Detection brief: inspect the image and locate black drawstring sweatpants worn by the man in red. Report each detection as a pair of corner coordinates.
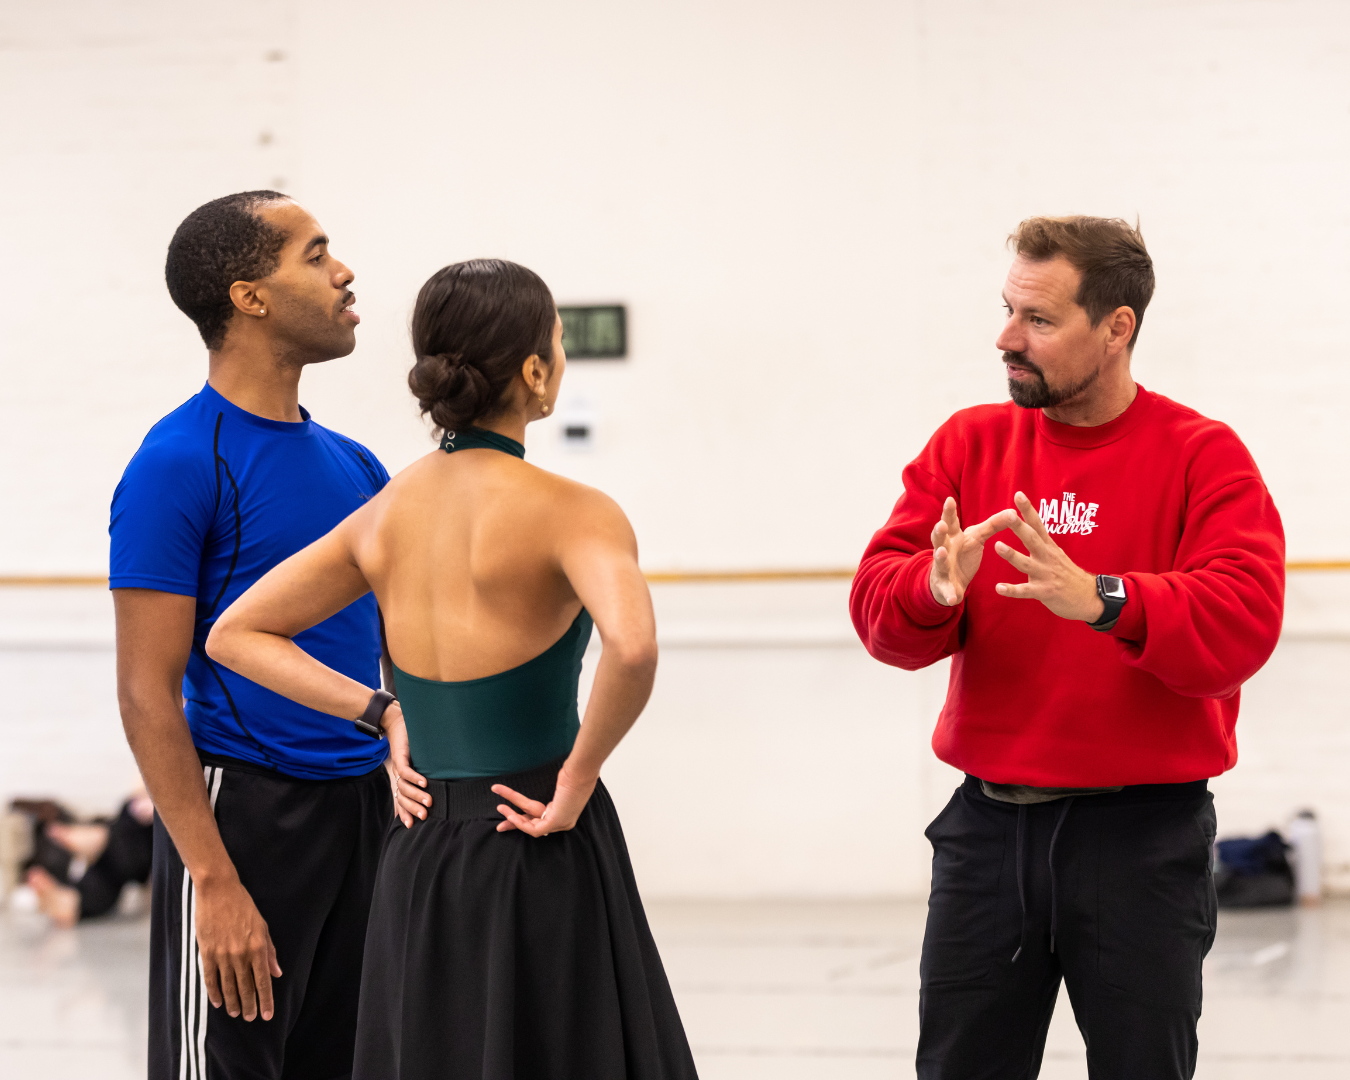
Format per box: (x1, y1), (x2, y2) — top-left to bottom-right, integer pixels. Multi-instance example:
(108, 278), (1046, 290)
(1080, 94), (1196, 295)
(918, 776), (1216, 1080)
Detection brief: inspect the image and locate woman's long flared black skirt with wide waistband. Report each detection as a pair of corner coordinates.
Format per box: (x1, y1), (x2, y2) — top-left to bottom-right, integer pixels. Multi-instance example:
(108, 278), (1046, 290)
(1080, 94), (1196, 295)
(352, 761), (697, 1080)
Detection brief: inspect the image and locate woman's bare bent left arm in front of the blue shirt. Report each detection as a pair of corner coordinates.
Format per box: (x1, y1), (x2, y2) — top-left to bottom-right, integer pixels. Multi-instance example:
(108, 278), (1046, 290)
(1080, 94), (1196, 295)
(207, 518), (431, 826)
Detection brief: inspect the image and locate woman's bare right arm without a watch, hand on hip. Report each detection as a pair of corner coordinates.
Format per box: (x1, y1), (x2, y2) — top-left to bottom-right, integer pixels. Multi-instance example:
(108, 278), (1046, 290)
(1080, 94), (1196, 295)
(493, 493), (656, 837)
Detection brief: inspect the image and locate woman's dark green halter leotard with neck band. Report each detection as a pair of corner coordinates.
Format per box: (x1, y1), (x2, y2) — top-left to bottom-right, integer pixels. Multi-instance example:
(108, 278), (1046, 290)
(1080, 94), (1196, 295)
(394, 428), (591, 780)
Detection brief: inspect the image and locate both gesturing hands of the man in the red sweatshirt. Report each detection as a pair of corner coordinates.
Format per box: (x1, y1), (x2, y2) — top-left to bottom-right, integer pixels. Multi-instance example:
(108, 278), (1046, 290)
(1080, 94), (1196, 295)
(929, 491), (1104, 622)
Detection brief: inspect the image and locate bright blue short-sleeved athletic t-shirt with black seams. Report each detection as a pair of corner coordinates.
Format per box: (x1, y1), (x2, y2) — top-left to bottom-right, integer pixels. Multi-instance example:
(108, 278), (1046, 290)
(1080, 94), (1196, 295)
(108, 383), (389, 779)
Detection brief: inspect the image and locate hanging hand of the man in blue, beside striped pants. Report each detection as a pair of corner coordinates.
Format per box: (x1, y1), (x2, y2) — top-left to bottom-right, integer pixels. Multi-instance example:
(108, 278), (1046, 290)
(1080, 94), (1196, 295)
(195, 878), (281, 1021)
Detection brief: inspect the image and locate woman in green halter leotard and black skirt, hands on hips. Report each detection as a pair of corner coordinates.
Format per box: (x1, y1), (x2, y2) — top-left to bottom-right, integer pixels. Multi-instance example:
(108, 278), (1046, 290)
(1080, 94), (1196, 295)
(207, 261), (695, 1080)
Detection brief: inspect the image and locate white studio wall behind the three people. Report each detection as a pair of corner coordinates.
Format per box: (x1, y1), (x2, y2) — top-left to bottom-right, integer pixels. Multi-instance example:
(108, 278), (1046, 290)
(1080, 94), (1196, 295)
(0, 0), (1350, 894)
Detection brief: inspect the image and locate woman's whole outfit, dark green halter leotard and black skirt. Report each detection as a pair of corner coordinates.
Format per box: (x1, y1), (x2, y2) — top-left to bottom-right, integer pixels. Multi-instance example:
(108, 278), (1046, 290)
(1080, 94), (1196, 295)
(352, 428), (697, 1080)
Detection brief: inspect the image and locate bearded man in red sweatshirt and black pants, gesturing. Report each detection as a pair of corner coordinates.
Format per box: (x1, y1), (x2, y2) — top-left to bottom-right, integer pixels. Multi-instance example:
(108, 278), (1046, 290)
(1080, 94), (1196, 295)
(851, 217), (1284, 1080)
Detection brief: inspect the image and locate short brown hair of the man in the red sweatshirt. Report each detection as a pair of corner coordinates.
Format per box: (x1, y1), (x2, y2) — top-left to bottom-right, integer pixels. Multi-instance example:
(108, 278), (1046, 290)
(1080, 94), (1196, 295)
(1008, 215), (1153, 348)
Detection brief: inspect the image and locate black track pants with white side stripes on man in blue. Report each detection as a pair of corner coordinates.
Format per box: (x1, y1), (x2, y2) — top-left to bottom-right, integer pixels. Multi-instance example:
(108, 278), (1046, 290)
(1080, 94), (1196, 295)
(149, 757), (393, 1080)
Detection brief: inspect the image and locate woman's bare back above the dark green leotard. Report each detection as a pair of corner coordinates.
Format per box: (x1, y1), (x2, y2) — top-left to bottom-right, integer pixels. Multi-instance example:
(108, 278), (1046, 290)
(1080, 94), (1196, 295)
(350, 448), (607, 682)
